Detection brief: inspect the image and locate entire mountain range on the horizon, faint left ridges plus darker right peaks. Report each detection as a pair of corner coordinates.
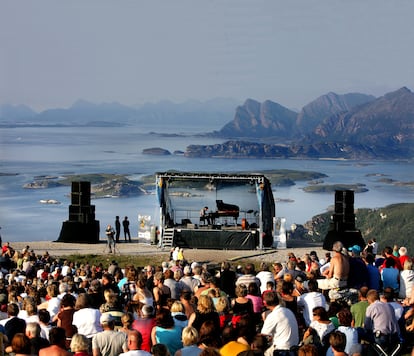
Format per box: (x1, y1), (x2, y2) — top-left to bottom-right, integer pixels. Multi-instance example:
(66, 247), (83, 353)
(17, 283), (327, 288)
(0, 87), (414, 159)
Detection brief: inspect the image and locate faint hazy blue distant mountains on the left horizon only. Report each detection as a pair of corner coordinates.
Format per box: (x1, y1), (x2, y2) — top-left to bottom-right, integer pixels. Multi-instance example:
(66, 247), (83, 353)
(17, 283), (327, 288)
(0, 98), (238, 130)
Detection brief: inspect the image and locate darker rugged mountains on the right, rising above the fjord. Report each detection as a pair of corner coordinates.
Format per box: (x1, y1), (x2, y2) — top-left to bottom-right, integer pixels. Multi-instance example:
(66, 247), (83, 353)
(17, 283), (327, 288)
(209, 87), (414, 159)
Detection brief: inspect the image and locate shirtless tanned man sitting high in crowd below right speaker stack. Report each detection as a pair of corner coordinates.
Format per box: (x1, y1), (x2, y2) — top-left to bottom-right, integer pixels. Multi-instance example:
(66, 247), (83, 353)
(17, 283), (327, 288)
(317, 241), (349, 290)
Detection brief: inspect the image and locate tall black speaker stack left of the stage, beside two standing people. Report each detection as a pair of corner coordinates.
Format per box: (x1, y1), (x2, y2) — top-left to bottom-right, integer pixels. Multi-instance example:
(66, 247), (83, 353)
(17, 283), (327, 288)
(58, 181), (99, 243)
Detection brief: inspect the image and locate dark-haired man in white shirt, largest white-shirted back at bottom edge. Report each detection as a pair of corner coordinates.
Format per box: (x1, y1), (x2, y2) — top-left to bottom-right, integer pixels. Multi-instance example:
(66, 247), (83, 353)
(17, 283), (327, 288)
(261, 291), (299, 356)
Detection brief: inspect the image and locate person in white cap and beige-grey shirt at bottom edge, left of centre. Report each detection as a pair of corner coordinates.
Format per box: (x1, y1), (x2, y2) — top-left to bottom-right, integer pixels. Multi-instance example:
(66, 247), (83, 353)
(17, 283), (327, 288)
(92, 313), (127, 356)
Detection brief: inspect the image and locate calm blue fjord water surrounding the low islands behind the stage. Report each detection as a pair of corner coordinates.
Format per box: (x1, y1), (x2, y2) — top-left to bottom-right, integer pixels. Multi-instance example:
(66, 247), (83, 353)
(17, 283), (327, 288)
(0, 124), (414, 242)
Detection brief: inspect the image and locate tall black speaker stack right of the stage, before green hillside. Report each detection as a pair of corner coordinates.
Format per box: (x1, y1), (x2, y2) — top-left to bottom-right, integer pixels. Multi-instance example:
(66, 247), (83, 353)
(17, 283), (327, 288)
(323, 190), (365, 251)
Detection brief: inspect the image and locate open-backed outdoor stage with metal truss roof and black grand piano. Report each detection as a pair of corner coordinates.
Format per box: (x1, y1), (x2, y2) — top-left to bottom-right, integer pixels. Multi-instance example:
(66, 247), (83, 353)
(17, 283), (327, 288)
(156, 172), (275, 250)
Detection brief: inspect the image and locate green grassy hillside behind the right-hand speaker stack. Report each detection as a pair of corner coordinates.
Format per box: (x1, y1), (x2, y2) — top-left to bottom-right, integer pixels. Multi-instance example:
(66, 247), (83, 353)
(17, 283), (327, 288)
(305, 203), (414, 256)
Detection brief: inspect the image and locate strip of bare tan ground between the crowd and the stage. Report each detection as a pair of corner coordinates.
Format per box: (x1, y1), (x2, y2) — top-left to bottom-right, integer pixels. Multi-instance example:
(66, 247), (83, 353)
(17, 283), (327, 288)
(11, 240), (326, 263)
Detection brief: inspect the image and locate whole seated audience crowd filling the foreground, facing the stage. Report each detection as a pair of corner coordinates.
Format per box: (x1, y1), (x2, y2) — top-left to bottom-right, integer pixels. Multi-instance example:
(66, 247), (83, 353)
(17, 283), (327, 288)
(0, 241), (414, 356)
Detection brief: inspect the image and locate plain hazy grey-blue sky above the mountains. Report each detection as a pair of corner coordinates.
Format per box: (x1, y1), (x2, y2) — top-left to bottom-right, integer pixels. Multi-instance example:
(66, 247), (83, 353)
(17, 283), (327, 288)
(0, 0), (414, 110)
